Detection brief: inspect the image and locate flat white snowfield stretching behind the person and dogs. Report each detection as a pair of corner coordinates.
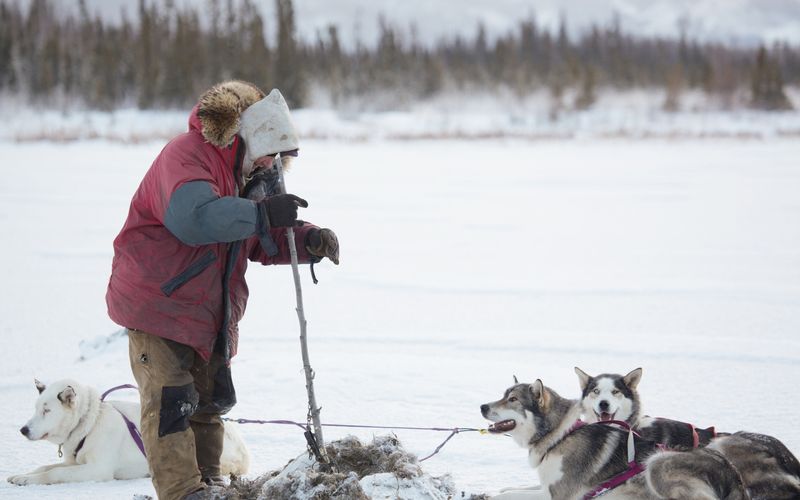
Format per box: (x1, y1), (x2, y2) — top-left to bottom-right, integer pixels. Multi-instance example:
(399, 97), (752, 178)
(0, 138), (800, 499)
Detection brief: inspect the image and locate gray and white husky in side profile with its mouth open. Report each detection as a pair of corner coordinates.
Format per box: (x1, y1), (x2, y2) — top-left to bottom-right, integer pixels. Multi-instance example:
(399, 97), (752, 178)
(481, 380), (749, 500)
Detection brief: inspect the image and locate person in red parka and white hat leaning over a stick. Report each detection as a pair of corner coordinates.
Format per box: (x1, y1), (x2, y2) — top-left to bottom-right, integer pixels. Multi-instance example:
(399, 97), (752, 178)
(106, 81), (339, 500)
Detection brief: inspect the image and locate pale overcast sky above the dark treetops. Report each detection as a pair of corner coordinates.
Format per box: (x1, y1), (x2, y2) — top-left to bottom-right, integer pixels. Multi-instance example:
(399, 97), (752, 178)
(28, 0), (800, 45)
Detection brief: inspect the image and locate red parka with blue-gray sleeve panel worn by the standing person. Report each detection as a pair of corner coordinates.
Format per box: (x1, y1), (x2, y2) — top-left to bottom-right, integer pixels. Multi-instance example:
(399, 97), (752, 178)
(106, 86), (314, 359)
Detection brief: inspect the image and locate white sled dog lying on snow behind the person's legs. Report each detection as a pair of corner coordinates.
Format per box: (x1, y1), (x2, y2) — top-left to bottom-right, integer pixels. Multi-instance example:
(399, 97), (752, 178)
(8, 379), (250, 485)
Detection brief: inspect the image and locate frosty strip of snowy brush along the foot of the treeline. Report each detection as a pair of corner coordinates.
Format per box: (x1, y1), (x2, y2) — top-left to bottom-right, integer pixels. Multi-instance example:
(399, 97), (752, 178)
(0, 87), (800, 144)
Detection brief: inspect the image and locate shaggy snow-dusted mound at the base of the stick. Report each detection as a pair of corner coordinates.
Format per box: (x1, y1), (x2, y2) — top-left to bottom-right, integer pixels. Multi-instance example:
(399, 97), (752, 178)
(227, 436), (456, 500)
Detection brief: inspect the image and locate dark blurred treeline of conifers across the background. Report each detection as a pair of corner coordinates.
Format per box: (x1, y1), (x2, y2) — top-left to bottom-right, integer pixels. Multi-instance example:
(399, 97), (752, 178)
(0, 0), (800, 109)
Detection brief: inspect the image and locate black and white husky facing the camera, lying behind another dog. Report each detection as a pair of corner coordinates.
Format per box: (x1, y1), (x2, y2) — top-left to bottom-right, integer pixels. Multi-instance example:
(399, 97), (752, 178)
(575, 367), (800, 500)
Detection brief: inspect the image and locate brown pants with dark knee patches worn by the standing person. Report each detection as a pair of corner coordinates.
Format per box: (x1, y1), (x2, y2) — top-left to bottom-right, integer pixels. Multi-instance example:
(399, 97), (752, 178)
(128, 330), (236, 500)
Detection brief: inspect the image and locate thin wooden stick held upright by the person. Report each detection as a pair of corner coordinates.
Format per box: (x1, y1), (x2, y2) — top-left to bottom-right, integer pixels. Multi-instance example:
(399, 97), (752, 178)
(275, 155), (328, 465)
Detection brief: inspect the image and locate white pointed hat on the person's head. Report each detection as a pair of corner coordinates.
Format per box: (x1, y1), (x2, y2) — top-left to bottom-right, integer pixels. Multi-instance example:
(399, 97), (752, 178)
(239, 89), (298, 163)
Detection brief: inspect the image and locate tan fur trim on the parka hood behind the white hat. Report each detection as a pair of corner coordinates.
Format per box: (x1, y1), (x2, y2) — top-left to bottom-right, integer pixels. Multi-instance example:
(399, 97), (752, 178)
(197, 80), (265, 148)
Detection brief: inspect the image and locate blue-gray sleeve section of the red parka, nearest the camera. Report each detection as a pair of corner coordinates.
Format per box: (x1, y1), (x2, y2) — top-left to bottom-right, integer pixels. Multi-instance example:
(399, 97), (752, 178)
(164, 181), (258, 246)
